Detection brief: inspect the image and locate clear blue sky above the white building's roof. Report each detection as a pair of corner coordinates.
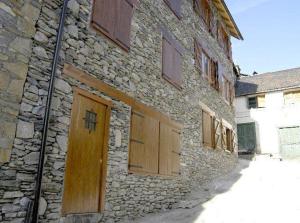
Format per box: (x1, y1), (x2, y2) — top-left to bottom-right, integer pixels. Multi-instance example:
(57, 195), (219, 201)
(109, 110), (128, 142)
(225, 0), (300, 74)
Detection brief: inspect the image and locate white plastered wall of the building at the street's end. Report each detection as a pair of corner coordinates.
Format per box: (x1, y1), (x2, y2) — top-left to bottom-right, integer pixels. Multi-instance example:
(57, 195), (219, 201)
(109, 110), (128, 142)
(235, 92), (300, 154)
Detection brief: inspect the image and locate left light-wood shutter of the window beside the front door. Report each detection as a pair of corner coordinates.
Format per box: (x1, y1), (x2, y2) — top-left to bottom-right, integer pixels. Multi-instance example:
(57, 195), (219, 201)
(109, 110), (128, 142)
(129, 111), (159, 173)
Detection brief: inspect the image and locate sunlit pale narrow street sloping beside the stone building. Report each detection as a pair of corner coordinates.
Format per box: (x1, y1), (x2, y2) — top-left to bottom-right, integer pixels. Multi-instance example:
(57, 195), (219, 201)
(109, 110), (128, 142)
(135, 157), (300, 223)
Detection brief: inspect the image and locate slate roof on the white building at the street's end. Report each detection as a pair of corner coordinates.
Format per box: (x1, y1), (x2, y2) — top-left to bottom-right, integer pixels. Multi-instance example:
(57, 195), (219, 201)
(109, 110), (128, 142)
(235, 67), (300, 97)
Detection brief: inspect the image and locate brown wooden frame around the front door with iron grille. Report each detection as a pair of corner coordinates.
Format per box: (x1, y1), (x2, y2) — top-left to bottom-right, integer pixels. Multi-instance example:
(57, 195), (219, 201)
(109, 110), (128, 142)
(62, 87), (113, 216)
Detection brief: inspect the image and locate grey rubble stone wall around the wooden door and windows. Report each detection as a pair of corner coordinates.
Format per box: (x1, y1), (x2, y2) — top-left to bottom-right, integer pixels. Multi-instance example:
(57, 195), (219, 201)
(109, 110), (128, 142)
(0, 0), (236, 222)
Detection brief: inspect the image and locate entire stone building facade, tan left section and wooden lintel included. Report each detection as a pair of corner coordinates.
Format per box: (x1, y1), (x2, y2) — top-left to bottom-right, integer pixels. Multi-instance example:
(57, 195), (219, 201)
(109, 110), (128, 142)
(0, 0), (241, 222)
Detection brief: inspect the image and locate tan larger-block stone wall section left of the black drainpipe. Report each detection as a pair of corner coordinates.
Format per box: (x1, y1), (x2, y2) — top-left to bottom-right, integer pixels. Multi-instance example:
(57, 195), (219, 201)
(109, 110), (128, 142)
(0, 0), (41, 165)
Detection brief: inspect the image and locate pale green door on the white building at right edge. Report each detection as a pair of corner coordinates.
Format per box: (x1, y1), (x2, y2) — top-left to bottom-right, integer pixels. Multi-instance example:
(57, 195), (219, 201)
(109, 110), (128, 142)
(279, 126), (300, 158)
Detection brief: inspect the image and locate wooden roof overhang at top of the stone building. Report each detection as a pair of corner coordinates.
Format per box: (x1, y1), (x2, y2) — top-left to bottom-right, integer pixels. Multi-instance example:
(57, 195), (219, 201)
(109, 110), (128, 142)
(213, 0), (244, 40)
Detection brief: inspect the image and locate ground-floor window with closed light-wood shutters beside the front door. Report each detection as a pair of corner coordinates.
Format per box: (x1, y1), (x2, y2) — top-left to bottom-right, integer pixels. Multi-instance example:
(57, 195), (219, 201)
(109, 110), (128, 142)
(129, 111), (180, 176)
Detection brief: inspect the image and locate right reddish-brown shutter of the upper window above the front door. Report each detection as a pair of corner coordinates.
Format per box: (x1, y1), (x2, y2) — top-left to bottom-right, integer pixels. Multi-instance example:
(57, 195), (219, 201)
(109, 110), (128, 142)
(115, 0), (133, 49)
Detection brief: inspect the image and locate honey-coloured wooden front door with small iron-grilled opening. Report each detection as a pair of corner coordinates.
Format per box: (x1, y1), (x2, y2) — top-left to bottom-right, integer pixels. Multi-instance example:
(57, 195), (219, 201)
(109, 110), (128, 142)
(62, 88), (111, 214)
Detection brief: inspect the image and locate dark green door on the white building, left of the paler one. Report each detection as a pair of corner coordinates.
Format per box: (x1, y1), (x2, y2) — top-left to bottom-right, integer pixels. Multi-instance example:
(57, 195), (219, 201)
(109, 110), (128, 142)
(237, 122), (256, 153)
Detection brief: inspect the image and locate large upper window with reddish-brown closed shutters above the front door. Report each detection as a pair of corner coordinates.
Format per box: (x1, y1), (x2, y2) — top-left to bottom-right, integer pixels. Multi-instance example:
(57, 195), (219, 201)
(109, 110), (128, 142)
(91, 0), (136, 51)
